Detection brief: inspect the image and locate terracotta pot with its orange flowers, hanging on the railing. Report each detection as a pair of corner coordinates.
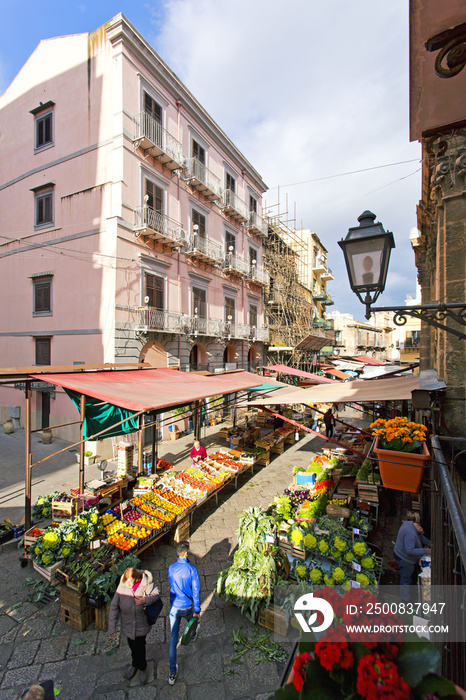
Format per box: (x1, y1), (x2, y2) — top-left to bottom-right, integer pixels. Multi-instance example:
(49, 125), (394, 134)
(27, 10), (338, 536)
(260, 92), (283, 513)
(371, 417), (430, 493)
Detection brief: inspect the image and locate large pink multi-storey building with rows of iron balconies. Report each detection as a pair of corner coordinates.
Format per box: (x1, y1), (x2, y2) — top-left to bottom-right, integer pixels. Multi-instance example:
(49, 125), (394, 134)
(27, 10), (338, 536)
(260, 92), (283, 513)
(0, 14), (268, 438)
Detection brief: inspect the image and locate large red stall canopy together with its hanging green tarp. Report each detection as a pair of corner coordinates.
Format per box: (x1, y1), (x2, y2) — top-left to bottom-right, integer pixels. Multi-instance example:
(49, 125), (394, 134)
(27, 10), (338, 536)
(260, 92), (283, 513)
(30, 369), (264, 439)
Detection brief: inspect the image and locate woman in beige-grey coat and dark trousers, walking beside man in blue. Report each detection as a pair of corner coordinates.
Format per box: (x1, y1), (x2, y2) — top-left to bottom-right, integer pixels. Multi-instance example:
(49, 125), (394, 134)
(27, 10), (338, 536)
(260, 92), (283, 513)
(108, 567), (160, 685)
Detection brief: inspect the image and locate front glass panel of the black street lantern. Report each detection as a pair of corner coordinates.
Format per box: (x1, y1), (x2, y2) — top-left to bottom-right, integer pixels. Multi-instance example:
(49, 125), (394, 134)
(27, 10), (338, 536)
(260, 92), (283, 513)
(346, 238), (385, 288)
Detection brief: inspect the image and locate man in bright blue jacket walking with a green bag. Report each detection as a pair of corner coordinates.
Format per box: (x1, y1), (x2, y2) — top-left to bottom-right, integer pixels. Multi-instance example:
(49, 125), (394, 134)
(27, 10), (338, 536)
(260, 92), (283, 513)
(168, 542), (201, 685)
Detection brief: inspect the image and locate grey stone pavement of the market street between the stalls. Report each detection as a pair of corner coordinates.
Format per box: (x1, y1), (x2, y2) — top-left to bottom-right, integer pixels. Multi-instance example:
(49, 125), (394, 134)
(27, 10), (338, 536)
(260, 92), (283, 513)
(0, 417), (386, 700)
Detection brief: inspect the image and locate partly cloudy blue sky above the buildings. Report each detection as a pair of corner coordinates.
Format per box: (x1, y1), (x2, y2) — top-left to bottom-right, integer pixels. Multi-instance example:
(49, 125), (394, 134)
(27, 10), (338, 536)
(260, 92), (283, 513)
(0, 0), (421, 320)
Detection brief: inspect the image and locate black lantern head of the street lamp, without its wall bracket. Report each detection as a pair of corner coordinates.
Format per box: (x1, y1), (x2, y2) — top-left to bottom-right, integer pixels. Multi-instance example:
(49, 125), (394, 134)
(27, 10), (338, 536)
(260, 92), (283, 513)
(338, 211), (395, 318)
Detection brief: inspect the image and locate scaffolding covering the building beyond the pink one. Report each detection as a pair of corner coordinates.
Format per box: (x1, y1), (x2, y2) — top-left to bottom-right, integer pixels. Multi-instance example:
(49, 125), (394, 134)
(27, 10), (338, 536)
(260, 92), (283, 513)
(264, 197), (333, 369)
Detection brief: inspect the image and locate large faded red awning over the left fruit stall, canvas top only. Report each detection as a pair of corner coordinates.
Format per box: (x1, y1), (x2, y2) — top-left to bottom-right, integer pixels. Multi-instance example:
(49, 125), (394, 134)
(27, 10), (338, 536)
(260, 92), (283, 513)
(30, 369), (264, 411)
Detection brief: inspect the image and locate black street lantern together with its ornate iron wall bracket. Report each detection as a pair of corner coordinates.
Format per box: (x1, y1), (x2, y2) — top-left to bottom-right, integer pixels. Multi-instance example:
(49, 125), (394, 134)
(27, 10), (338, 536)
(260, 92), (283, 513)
(338, 211), (466, 340)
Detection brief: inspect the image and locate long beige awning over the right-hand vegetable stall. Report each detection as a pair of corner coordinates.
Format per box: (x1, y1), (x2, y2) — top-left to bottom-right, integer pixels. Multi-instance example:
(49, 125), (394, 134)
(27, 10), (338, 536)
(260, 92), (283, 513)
(251, 377), (434, 406)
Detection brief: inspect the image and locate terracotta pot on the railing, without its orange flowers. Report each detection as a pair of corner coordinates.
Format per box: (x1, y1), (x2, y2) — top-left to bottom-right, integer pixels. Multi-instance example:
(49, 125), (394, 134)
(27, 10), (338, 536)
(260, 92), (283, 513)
(374, 438), (430, 493)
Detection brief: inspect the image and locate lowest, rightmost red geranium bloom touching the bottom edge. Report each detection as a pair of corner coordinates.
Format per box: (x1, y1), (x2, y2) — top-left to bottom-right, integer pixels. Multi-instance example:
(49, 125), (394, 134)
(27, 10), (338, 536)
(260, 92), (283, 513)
(356, 654), (411, 700)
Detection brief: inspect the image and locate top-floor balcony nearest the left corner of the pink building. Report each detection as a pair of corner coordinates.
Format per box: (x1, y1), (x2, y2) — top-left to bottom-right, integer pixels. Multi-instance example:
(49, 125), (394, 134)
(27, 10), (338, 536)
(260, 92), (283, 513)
(133, 112), (184, 170)
